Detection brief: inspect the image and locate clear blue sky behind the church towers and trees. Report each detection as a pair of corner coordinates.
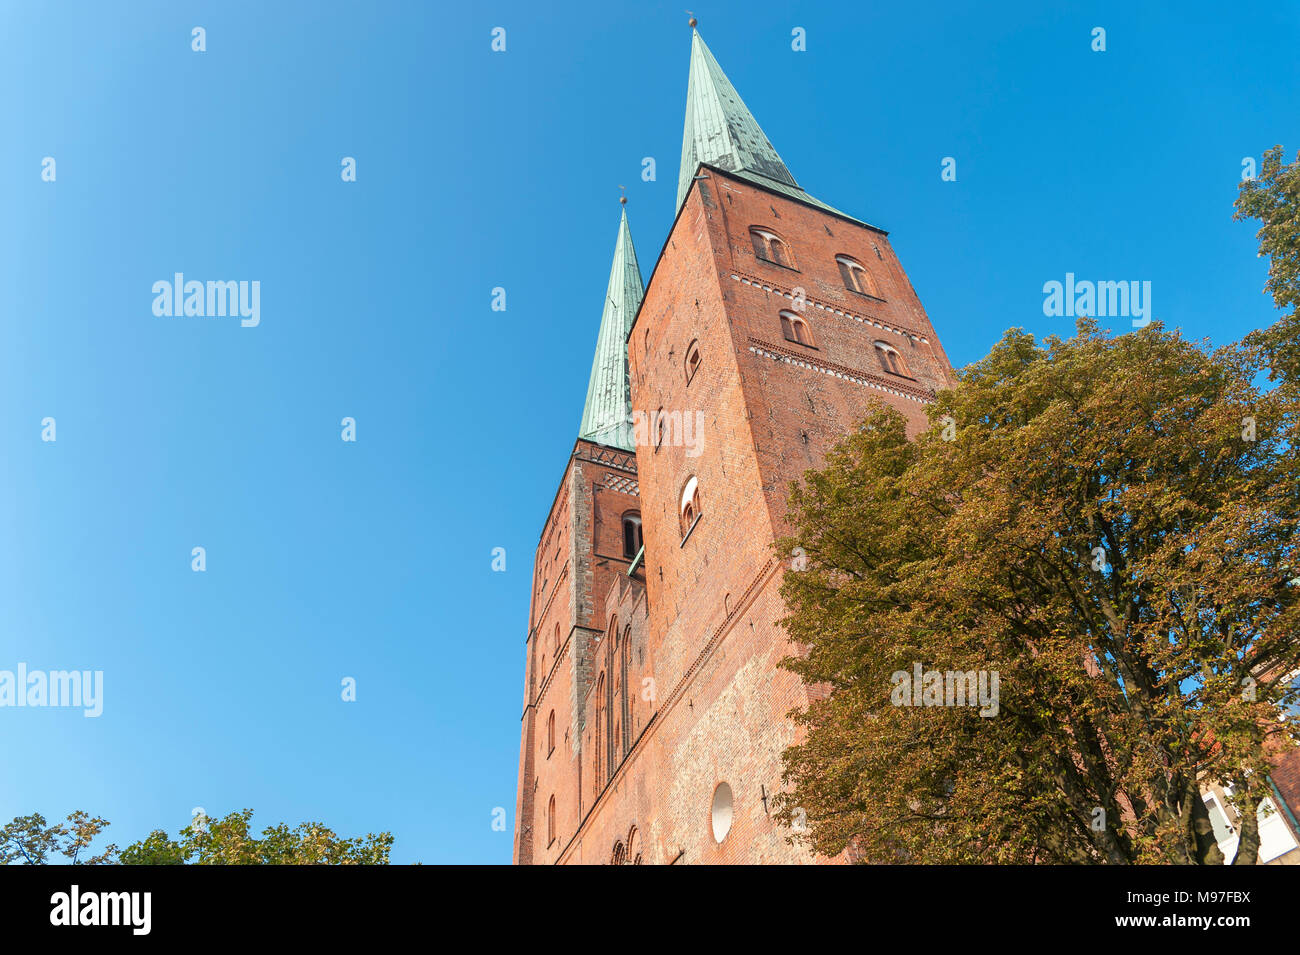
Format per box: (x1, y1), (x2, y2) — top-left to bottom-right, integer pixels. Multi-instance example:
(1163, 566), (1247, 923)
(0, 0), (1300, 863)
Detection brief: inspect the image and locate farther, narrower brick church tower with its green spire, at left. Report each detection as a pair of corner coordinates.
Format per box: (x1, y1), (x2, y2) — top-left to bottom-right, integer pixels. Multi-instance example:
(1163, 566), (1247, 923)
(515, 209), (645, 864)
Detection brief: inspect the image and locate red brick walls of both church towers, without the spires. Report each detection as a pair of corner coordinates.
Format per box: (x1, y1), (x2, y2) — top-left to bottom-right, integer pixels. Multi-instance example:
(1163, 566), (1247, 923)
(515, 165), (953, 864)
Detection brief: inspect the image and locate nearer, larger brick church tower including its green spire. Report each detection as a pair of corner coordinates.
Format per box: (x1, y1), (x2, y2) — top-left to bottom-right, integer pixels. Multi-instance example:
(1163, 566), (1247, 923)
(514, 23), (954, 864)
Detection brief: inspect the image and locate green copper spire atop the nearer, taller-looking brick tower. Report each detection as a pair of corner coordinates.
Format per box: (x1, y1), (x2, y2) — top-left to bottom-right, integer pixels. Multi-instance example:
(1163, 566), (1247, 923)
(677, 30), (837, 212)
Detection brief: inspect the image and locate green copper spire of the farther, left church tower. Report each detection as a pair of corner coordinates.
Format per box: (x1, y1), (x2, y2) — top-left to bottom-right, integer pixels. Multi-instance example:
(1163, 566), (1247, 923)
(579, 209), (645, 451)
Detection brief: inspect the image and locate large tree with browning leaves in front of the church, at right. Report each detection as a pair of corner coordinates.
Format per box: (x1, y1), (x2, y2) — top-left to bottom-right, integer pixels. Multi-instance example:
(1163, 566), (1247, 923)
(779, 149), (1300, 864)
